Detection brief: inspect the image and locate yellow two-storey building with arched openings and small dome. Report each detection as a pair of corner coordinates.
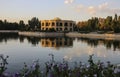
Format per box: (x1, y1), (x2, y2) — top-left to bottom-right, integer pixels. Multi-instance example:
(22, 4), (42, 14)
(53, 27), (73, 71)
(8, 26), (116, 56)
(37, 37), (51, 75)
(41, 17), (75, 32)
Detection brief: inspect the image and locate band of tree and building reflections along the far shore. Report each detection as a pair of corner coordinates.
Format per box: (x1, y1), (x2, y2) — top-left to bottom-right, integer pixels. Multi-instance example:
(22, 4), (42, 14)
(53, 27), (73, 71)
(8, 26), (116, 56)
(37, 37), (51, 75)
(0, 33), (120, 51)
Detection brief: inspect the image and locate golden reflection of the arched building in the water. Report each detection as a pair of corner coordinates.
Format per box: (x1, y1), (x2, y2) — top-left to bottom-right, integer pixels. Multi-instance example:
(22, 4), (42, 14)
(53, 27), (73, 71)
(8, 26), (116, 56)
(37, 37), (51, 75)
(41, 37), (73, 48)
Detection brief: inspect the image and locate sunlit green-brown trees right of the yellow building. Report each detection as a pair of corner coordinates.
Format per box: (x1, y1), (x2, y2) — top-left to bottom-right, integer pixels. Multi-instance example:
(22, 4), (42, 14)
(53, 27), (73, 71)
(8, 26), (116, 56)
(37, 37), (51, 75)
(75, 14), (120, 33)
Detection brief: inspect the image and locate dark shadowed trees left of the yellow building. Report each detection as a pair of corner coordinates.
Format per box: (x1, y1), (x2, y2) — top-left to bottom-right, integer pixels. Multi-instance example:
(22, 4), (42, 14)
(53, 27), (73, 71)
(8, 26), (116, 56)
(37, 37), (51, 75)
(0, 17), (40, 31)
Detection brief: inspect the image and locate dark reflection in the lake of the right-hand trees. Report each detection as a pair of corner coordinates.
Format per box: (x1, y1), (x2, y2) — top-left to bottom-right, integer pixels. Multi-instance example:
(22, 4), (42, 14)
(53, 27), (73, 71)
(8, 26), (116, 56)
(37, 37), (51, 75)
(77, 38), (120, 51)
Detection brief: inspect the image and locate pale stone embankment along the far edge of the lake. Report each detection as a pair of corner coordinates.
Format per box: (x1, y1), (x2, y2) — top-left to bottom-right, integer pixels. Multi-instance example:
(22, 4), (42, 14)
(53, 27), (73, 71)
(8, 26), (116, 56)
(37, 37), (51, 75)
(0, 30), (120, 40)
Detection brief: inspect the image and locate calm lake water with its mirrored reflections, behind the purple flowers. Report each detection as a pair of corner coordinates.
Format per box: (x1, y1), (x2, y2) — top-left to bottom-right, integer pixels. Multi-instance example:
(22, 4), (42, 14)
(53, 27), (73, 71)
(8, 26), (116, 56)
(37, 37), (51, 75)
(0, 33), (120, 72)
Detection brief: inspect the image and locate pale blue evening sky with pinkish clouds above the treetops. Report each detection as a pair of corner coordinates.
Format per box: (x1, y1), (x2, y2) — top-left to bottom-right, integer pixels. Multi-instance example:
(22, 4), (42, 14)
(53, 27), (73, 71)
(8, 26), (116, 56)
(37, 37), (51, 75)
(0, 0), (120, 23)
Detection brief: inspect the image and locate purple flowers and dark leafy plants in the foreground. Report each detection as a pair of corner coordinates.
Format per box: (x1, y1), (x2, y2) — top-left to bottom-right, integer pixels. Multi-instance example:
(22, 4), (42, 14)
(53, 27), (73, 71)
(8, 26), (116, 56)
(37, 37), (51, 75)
(0, 54), (120, 77)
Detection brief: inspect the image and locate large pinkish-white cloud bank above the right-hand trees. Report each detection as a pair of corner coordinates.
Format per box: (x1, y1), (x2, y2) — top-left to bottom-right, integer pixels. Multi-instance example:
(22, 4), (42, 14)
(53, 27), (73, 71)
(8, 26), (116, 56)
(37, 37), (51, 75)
(74, 2), (120, 15)
